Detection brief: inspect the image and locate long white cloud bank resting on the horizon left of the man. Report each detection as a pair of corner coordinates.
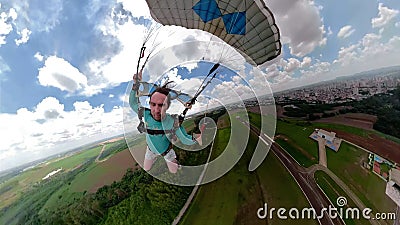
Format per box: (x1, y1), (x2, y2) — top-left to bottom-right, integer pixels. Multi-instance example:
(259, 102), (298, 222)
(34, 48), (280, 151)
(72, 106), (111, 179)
(0, 97), (123, 170)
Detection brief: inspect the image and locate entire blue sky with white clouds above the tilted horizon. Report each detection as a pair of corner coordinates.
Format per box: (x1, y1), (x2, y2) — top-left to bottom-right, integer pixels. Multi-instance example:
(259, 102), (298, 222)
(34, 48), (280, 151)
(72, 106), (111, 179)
(0, 0), (400, 171)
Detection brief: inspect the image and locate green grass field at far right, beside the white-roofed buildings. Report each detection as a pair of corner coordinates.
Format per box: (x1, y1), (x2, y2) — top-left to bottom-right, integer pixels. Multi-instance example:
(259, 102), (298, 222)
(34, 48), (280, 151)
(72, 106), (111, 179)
(327, 142), (395, 215)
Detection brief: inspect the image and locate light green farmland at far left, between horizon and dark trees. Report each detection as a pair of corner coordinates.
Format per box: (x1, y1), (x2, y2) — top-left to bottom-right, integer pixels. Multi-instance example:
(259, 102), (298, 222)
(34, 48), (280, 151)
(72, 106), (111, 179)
(0, 139), (138, 224)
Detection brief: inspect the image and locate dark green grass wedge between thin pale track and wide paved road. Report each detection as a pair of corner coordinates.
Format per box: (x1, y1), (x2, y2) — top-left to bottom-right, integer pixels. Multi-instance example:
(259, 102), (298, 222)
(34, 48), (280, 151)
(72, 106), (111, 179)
(180, 120), (317, 224)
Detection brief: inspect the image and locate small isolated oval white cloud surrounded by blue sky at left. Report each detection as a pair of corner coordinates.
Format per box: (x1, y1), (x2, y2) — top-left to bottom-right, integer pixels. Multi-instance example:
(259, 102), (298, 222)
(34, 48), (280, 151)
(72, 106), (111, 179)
(38, 56), (87, 93)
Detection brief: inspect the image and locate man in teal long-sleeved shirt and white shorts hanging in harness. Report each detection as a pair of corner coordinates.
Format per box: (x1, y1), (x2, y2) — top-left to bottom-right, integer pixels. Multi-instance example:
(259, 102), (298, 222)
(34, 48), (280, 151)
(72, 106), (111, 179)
(129, 71), (201, 173)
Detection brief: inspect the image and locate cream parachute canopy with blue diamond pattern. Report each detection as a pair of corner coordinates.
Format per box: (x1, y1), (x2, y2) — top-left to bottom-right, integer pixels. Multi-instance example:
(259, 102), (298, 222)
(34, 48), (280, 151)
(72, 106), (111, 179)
(146, 0), (281, 65)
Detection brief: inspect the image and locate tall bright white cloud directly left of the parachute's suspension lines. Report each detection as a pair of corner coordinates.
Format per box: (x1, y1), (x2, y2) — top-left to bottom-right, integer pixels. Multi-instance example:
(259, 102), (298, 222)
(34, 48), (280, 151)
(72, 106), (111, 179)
(81, 1), (155, 96)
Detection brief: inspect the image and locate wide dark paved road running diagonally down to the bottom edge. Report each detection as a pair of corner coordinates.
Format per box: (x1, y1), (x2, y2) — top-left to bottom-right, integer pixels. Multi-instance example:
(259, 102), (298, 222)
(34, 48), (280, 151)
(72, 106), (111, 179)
(243, 120), (345, 225)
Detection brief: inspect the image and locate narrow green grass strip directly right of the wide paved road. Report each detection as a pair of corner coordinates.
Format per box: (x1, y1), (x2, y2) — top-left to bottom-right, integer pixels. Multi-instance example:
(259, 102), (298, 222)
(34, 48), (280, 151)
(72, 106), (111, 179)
(315, 171), (369, 225)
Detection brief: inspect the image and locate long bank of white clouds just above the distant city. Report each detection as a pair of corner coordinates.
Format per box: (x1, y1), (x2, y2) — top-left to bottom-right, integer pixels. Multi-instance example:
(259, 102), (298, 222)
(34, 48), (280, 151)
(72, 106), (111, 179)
(274, 27), (400, 91)
